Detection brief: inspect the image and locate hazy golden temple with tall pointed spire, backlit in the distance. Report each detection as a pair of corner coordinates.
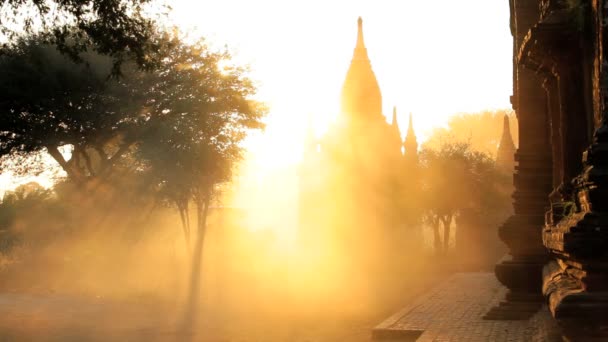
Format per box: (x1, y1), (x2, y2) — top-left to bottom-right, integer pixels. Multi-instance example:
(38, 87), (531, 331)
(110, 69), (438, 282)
(299, 18), (418, 264)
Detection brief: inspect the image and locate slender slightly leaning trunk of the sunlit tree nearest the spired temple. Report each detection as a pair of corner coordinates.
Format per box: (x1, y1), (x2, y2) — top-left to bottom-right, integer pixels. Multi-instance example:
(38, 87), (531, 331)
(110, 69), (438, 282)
(184, 198), (209, 340)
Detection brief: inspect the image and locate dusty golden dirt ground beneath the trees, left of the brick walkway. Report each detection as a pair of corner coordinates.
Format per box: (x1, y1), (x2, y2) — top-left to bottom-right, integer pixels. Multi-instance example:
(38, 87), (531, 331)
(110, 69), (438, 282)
(0, 278), (437, 342)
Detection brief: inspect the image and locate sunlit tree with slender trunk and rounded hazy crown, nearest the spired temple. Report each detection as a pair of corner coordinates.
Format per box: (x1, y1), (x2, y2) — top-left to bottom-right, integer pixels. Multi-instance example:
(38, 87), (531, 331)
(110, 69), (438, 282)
(138, 41), (265, 332)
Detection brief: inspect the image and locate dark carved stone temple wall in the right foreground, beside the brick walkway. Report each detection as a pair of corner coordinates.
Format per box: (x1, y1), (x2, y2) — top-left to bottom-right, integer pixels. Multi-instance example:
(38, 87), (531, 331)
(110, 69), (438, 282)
(491, 0), (608, 341)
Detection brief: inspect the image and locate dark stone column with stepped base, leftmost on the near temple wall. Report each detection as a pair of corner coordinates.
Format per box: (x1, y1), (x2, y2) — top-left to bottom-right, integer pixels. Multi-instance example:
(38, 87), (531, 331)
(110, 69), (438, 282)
(485, 0), (553, 319)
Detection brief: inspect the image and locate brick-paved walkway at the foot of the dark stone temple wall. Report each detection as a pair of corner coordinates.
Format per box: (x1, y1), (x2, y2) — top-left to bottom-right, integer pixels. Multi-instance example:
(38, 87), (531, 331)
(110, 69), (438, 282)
(373, 273), (557, 342)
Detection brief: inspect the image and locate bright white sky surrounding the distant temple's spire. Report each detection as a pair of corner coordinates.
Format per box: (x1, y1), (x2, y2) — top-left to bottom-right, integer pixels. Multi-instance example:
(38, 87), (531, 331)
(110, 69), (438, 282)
(171, 0), (512, 164)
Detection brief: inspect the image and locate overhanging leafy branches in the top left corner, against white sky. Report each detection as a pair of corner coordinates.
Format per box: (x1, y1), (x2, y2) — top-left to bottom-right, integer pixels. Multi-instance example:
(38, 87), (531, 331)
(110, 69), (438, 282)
(0, 0), (160, 74)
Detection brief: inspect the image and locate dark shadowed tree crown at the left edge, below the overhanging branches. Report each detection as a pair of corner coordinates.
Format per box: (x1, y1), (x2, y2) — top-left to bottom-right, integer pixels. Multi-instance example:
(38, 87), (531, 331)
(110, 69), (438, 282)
(0, 36), (150, 184)
